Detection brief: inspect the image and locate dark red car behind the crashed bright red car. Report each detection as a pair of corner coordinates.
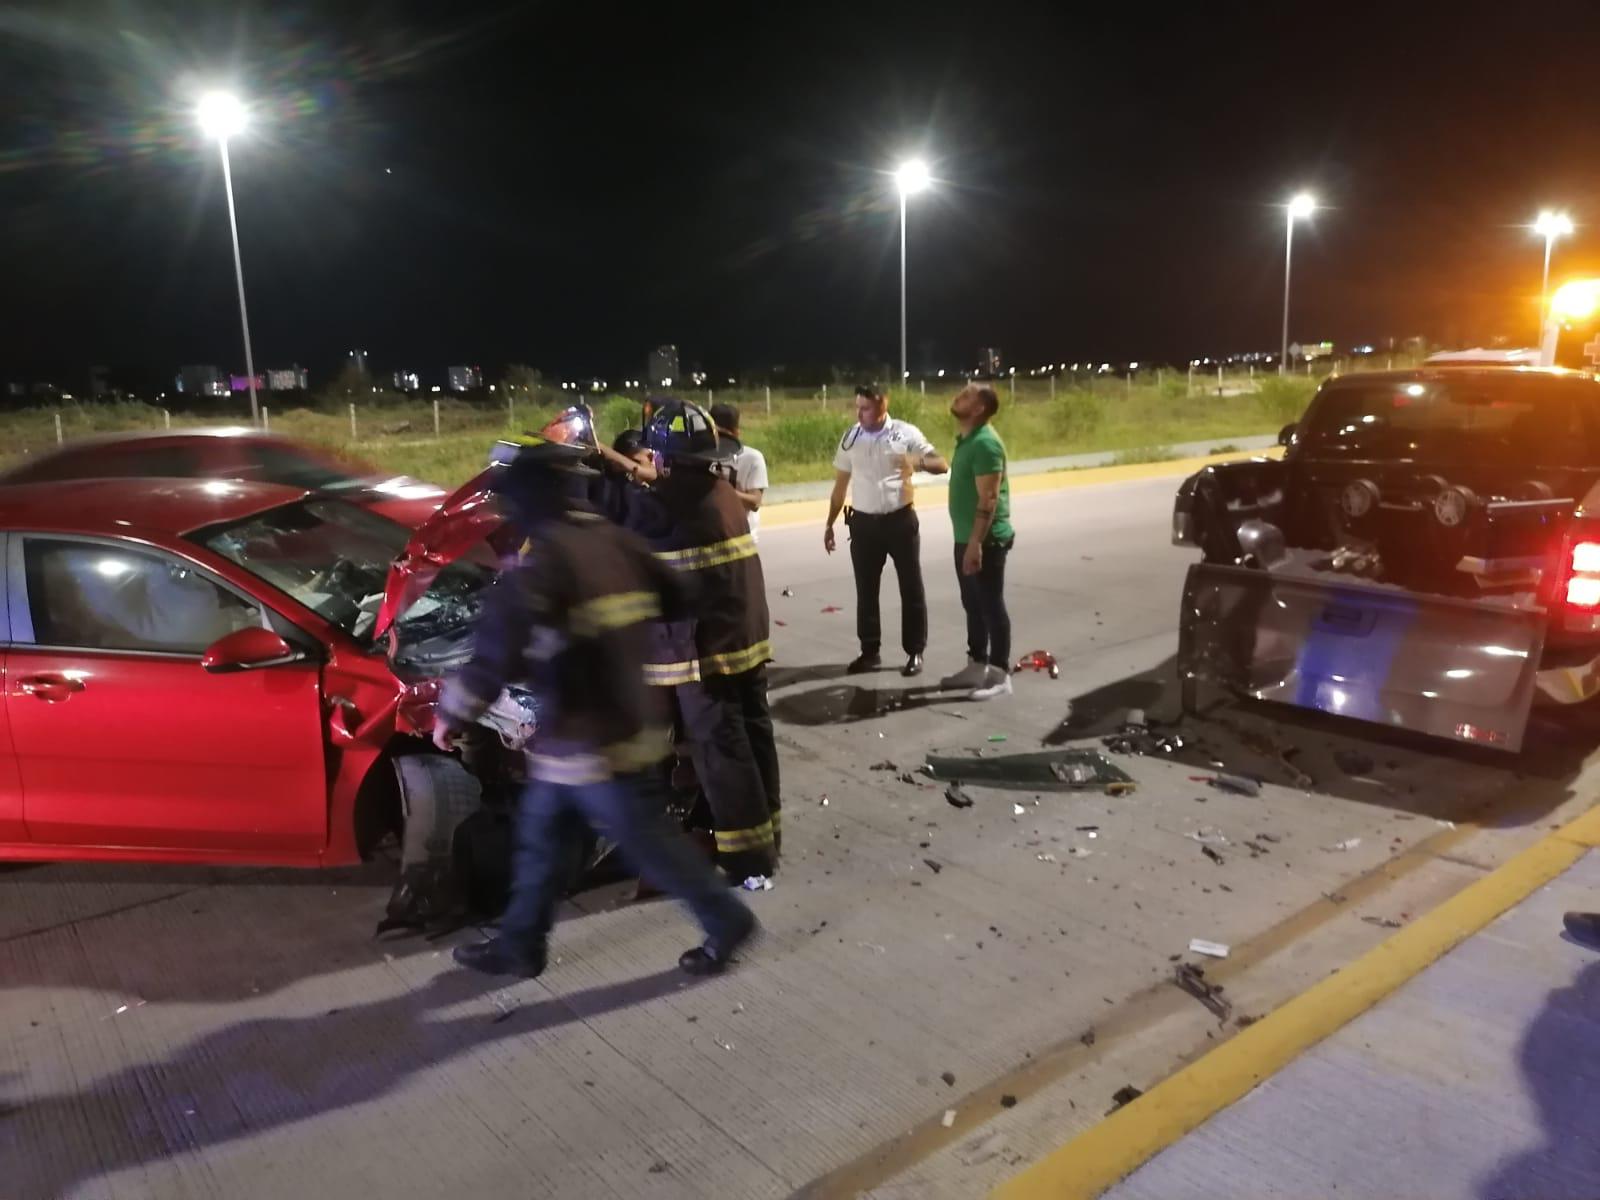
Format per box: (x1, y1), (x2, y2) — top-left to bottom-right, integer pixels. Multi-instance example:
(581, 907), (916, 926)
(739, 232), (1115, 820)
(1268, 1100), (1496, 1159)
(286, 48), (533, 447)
(0, 427), (445, 528)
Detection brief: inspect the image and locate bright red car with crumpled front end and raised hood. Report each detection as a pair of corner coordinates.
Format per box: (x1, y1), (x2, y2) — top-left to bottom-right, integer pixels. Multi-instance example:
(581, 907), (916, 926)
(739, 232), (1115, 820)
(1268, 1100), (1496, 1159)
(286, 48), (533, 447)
(0, 478), (533, 912)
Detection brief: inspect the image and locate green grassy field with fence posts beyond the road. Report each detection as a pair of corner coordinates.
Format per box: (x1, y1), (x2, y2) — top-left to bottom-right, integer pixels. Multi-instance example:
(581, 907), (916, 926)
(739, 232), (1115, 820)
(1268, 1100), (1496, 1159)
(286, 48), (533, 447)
(0, 371), (1318, 486)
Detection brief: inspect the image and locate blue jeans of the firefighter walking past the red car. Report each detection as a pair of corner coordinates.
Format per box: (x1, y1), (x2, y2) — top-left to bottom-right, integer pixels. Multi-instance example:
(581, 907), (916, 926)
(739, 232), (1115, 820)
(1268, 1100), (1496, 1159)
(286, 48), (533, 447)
(501, 773), (754, 946)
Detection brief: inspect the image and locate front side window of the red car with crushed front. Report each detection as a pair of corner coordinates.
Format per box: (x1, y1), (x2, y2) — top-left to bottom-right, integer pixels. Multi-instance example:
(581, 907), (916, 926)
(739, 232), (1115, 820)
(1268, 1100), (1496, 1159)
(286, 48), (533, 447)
(22, 538), (262, 654)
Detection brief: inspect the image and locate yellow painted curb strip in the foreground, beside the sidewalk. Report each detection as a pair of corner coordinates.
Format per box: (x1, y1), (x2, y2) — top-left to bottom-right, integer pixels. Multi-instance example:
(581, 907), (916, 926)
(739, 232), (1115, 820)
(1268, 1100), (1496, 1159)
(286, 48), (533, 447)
(992, 810), (1600, 1200)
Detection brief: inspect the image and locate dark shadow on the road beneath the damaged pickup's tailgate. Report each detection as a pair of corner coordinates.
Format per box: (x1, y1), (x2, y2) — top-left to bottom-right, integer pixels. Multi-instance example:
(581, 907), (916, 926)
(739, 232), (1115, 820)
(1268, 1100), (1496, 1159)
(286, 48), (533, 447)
(1043, 658), (1600, 826)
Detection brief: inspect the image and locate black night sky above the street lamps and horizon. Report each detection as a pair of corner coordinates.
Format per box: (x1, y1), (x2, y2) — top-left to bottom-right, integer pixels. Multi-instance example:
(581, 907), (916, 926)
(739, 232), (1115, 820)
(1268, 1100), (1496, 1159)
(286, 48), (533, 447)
(0, 0), (1600, 379)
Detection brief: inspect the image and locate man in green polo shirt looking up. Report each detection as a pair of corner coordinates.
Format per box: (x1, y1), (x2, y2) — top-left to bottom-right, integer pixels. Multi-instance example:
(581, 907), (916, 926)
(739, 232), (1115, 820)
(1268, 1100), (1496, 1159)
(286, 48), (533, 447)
(939, 384), (1016, 699)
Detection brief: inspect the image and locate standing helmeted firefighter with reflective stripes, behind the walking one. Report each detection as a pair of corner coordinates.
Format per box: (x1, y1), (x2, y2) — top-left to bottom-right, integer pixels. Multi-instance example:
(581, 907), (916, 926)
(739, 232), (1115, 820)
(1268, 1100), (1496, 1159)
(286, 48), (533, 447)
(645, 400), (782, 880)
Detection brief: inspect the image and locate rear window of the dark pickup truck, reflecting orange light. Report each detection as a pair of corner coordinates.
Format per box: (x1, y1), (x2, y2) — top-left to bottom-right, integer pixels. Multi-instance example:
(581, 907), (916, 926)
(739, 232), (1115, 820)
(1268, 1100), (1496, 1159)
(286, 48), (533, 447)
(1299, 371), (1600, 467)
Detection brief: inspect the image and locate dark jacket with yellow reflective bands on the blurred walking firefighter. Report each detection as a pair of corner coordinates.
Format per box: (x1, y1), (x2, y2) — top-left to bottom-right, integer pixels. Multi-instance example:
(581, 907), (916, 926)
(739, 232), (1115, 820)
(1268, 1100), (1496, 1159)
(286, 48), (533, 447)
(440, 510), (686, 784)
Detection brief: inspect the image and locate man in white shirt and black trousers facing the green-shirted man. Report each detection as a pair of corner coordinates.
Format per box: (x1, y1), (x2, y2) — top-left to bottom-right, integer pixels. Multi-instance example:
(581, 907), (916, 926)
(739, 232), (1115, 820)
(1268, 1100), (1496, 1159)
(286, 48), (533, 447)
(822, 384), (950, 677)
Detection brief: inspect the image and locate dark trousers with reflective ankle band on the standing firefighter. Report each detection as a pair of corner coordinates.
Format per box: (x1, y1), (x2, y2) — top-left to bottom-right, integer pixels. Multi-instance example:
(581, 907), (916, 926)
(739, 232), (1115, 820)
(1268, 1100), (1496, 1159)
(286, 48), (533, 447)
(677, 667), (782, 880)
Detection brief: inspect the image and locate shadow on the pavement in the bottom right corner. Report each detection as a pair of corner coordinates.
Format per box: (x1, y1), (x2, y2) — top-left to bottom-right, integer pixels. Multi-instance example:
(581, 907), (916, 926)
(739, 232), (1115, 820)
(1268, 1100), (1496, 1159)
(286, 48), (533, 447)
(1478, 962), (1600, 1200)
